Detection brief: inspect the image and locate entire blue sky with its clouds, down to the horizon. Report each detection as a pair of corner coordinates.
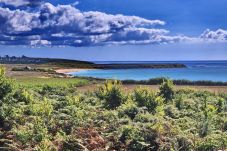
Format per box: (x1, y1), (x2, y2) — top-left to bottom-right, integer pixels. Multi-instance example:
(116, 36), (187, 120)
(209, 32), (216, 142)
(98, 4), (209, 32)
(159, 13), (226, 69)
(0, 0), (227, 61)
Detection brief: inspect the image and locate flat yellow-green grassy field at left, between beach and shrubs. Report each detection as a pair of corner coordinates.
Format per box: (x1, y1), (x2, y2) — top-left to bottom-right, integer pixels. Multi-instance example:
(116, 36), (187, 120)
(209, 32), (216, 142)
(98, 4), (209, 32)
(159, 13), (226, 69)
(1, 64), (94, 88)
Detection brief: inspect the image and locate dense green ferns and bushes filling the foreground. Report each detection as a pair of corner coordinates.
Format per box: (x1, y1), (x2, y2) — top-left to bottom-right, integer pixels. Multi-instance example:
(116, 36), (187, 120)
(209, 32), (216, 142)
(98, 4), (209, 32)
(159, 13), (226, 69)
(0, 68), (227, 151)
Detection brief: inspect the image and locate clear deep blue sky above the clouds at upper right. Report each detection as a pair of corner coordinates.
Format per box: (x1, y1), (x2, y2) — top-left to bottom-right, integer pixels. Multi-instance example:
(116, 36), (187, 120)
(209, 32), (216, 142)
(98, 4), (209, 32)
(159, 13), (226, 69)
(49, 0), (227, 35)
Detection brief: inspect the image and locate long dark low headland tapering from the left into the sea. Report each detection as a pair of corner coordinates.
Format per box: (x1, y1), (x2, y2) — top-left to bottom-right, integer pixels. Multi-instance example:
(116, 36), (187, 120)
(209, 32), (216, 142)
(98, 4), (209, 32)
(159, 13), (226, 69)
(0, 56), (186, 69)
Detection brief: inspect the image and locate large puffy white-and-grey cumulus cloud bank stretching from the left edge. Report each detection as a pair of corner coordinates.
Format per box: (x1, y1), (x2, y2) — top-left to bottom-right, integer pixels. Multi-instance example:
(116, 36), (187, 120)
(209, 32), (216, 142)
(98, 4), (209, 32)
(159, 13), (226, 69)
(0, 0), (209, 47)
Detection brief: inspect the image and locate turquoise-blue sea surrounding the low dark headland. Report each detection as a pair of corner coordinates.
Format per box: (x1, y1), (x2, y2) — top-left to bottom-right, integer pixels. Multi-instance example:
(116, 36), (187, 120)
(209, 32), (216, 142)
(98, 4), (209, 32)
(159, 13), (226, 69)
(70, 61), (227, 82)
